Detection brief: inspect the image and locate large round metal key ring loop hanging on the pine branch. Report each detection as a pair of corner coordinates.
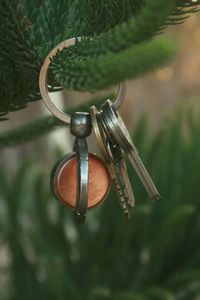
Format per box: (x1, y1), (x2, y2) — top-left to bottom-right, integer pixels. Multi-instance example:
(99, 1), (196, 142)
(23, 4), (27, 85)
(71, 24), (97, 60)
(39, 37), (126, 124)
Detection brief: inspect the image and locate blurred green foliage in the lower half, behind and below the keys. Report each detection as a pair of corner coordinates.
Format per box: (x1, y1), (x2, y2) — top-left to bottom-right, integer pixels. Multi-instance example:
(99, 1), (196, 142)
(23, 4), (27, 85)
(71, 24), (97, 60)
(0, 106), (200, 300)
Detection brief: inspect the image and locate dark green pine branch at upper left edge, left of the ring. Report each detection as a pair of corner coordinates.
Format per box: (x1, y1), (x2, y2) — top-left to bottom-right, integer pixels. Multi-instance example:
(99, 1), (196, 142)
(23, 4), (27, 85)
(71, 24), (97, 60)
(0, 0), (41, 114)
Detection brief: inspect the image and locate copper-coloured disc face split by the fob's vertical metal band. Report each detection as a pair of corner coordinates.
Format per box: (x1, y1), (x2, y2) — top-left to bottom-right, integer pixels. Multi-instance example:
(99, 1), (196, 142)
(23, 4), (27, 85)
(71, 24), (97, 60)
(53, 153), (111, 208)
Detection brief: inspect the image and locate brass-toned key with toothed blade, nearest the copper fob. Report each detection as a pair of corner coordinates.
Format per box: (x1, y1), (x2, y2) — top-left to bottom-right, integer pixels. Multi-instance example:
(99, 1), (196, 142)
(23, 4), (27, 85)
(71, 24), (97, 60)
(90, 106), (129, 218)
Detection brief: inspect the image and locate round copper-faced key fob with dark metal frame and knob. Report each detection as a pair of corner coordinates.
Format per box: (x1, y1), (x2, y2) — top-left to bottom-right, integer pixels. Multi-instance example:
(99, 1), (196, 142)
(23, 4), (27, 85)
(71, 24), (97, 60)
(50, 112), (111, 224)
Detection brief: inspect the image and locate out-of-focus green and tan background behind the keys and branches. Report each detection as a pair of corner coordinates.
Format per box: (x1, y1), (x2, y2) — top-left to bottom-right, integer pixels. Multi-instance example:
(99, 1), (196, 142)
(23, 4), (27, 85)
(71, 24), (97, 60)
(0, 5), (200, 300)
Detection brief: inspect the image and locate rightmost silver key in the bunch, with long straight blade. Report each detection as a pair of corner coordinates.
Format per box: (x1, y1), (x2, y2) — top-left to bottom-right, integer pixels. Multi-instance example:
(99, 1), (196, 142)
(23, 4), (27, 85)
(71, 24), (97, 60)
(100, 100), (160, 200)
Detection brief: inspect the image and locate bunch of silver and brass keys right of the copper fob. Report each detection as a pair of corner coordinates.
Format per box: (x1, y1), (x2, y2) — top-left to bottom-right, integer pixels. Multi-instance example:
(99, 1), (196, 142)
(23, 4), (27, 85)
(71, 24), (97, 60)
(90, 100), (160, 217)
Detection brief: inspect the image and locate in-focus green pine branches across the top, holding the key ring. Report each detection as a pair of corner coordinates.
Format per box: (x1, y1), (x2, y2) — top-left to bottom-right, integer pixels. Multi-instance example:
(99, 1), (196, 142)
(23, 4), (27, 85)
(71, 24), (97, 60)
(0, 0), (200, 120)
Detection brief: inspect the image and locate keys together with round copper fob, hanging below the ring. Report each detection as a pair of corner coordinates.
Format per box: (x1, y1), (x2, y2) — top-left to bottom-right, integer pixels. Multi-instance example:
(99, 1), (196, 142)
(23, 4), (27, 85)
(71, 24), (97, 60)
(51, 100), (160, 224)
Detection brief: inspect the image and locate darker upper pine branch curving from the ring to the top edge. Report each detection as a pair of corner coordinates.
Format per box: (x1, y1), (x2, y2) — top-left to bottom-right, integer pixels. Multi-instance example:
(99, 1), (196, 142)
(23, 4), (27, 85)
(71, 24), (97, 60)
(55, 0), (174, 59)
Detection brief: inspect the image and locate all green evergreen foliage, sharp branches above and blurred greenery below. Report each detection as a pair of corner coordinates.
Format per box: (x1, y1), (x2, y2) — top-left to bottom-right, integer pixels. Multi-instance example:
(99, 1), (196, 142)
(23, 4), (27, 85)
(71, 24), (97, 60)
(0, 0), (200, 300)
